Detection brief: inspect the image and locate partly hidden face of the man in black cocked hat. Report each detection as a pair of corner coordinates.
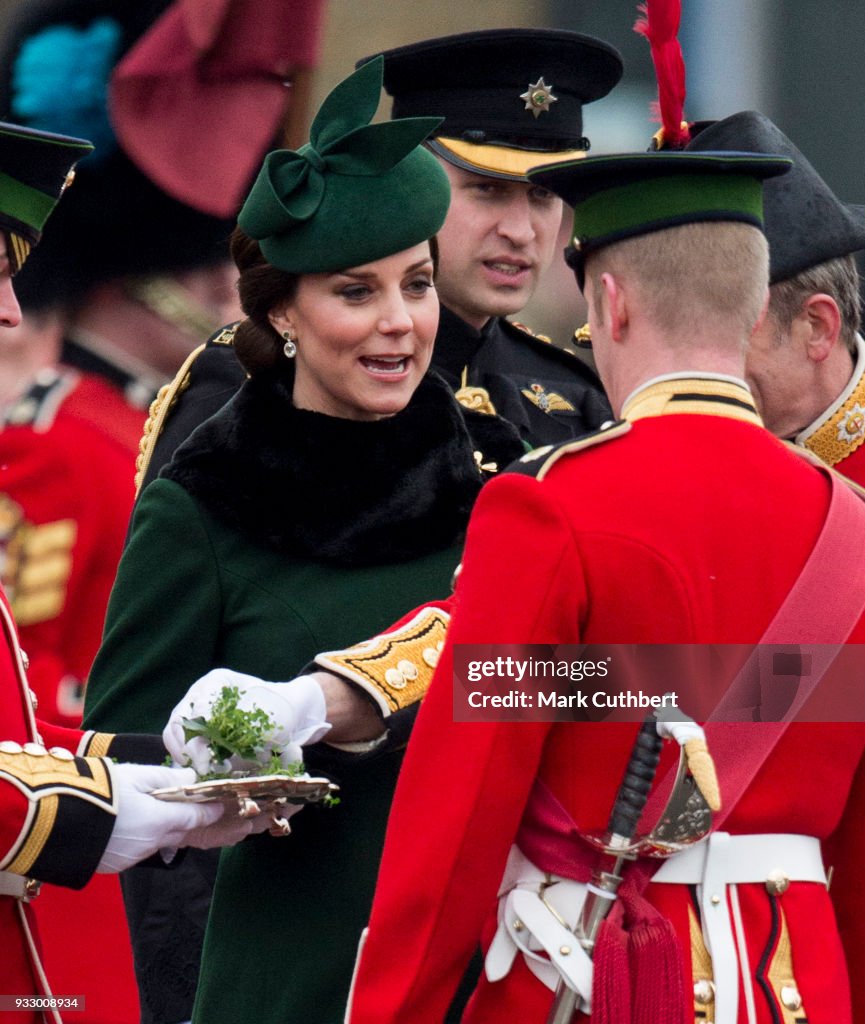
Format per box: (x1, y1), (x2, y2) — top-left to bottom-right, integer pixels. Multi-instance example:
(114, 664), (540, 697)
(745, 313), (819, 437)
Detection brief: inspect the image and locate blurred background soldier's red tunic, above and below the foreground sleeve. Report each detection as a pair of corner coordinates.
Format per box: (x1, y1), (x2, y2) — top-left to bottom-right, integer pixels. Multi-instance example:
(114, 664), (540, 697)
(0, 368), (143, 1024)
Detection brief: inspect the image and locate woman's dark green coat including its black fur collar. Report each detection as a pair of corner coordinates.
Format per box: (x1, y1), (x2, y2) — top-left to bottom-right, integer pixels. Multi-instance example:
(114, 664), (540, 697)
(85, 370), (495, 1024)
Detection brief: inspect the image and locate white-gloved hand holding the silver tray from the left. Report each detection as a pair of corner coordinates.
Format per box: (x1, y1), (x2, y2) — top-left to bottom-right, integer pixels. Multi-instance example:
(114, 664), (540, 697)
(96, 764), (270, 873)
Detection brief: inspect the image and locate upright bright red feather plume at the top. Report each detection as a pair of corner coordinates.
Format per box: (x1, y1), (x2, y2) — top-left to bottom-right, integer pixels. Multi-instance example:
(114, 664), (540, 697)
(634, 0), (691, 150)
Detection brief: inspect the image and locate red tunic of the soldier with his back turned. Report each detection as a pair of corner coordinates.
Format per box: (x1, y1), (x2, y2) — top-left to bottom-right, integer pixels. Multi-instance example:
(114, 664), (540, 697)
(349, 379), (865, 1024)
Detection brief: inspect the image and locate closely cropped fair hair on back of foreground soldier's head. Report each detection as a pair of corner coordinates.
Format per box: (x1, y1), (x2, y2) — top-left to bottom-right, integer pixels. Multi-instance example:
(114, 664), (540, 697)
(587, 221), (769, 340)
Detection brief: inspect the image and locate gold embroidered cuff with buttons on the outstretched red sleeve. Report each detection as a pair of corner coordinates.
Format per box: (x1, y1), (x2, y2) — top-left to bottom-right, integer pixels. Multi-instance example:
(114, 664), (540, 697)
(315, 607), (450, 718)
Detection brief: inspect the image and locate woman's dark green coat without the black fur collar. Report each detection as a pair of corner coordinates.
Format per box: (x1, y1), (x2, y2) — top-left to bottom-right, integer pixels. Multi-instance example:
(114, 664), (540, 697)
(87, 479), (460, 1024)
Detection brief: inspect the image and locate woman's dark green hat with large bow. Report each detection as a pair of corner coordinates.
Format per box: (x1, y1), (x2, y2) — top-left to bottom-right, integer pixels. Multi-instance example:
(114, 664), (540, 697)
(237, 57), (450, 273)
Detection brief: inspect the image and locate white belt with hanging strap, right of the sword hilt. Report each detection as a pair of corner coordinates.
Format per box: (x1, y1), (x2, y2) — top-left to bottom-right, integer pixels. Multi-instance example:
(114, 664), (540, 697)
(652, 833), (826, 1024)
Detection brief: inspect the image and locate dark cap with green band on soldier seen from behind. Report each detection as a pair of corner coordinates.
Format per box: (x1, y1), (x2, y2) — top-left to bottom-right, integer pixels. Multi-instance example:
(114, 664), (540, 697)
(529, 151), (792, 287)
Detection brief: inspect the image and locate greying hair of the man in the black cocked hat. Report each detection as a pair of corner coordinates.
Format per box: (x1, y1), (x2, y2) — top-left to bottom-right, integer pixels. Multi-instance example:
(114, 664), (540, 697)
(769, 255), (860, 357)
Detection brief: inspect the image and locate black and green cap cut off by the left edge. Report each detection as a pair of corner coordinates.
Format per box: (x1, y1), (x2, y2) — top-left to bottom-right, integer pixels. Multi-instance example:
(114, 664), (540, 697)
(0, 122), (93, 273)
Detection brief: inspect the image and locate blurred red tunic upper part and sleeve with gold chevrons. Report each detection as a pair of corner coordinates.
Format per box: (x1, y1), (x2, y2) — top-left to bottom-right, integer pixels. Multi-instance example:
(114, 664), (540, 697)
(0, 369), (140, 727)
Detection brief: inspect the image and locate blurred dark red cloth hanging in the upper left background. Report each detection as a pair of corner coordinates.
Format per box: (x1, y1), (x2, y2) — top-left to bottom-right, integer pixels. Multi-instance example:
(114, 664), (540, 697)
(109, 0), (325, 217)
